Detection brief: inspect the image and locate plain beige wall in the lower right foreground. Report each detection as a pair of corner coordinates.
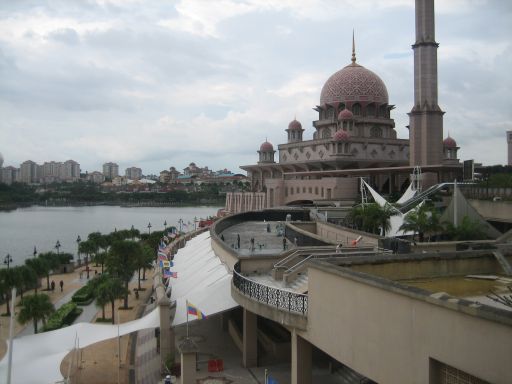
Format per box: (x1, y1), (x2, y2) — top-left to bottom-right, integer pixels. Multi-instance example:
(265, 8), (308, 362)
(300, 267), (512, 384)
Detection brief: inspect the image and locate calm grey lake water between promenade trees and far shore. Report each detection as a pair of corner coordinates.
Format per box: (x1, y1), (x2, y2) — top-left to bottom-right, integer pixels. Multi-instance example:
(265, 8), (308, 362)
(0, 206), (219, 268)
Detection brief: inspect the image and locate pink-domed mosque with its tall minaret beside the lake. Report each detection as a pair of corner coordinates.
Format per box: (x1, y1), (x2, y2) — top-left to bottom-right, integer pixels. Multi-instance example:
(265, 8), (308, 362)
(226, 11), (462, 213)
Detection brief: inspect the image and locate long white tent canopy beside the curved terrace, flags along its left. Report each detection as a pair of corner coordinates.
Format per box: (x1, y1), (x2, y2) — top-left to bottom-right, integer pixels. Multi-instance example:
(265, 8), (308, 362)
(168, 232), (238, 326)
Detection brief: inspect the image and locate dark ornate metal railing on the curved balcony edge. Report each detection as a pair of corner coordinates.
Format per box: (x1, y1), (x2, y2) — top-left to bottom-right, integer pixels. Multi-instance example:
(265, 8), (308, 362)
(233, 262), (308, 316)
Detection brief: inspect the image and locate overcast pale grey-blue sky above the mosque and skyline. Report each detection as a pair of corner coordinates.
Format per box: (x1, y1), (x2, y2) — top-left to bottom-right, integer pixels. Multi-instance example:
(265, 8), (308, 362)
(0, 0), (512, 174)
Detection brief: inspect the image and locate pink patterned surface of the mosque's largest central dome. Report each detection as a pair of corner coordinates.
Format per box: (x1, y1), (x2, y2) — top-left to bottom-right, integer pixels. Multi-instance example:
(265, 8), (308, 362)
(320, 63), (388, 105)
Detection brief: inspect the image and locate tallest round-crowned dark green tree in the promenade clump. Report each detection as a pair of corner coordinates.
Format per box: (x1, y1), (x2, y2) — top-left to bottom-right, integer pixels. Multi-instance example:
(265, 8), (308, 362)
(106, 240), (142, 309)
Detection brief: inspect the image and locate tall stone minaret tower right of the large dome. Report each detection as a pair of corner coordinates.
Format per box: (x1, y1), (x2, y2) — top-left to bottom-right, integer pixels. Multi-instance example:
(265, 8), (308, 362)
(409, 0), (444, 185)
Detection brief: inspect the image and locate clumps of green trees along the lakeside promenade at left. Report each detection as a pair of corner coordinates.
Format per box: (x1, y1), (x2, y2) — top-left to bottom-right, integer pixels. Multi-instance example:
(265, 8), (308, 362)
(0, 228), (163, 333)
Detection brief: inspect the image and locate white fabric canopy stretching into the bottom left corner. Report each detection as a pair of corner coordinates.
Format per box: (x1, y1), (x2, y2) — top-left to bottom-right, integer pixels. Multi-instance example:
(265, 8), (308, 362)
(0, 307), (160, 384)
